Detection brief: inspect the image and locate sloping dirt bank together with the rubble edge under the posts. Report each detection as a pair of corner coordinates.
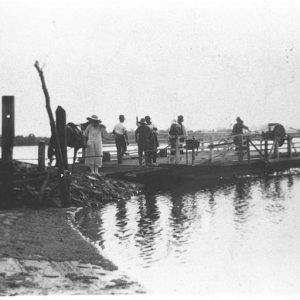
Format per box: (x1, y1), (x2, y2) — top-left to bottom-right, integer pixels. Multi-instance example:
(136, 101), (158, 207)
(0, 162), (145, 296)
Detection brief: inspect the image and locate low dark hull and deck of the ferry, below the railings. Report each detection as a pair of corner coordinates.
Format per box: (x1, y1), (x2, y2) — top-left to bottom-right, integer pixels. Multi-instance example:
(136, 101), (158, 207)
(75, 144), (300, 182)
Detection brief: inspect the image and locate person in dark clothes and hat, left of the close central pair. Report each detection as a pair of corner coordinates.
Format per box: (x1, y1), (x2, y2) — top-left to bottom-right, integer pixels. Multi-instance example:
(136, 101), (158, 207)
(135, 118), (152, 166)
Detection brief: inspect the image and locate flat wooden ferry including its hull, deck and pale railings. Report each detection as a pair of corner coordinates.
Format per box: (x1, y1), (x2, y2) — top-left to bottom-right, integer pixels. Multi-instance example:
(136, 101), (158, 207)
(96, 127), (300, 182)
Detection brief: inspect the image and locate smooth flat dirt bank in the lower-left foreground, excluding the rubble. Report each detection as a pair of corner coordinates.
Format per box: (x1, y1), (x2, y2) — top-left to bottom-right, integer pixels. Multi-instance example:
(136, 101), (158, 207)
(0, 208), (144, 296)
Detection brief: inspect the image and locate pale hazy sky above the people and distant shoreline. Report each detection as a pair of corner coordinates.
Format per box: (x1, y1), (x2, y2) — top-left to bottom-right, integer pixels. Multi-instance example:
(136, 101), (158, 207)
(0, 0), (300, 136)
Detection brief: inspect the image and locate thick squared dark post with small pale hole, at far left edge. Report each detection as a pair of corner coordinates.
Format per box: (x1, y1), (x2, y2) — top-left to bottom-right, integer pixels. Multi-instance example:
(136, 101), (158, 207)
(0, 96), (15, 208)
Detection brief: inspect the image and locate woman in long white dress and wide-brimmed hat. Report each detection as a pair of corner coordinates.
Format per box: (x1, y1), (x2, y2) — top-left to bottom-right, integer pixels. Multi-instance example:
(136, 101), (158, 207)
(84, 115), (105, 175)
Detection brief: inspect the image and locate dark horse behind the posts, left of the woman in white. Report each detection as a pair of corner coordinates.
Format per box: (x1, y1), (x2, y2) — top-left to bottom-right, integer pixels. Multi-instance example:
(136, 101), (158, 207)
(48, 122), (86, 169)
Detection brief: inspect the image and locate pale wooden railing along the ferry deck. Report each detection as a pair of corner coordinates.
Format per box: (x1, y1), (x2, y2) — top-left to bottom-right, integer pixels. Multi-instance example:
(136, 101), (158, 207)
(168, 133), (300, 165)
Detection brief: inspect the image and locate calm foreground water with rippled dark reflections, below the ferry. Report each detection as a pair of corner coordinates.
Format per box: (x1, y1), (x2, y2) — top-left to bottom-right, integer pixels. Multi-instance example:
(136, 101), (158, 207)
(76, 170), (300, 293)
